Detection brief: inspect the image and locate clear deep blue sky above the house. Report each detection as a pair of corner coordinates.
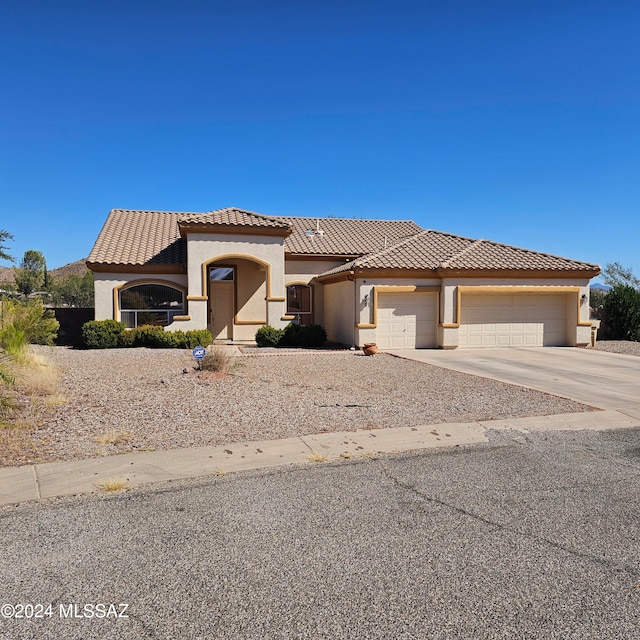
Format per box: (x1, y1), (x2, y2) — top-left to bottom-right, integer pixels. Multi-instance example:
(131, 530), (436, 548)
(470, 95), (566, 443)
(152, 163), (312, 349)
(0, 0), (640, 282)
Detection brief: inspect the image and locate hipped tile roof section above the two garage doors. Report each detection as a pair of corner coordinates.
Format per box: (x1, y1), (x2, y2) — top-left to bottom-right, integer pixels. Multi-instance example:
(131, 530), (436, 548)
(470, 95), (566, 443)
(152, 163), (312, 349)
(322, 229), (600, 276)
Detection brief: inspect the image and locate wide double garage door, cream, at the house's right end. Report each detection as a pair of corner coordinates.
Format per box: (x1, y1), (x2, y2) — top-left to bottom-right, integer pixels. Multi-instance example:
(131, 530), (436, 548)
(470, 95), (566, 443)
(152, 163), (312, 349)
(459, 293), (567, 347)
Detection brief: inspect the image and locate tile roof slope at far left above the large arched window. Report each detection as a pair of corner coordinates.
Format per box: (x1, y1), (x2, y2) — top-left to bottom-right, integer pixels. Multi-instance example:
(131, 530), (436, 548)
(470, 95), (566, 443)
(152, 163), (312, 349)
(87, 209), (193, 265)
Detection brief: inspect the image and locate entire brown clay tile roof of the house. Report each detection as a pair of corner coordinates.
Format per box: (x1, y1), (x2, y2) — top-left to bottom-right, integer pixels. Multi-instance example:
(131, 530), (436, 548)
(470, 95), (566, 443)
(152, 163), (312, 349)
(87, 208), (600, 275)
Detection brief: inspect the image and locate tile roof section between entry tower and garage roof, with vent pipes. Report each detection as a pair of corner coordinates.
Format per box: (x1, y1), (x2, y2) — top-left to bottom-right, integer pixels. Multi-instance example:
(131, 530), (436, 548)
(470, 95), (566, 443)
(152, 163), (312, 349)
(278, 216), (422, 257)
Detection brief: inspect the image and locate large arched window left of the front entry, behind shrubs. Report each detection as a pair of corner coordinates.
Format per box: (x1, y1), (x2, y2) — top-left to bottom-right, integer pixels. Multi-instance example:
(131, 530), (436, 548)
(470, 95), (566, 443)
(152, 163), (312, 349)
(120, 284), (184, 329)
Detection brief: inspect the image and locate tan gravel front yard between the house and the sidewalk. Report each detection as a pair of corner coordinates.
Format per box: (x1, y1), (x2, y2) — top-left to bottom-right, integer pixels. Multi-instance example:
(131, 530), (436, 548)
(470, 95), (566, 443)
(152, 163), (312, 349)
(0, 347), (588, 465)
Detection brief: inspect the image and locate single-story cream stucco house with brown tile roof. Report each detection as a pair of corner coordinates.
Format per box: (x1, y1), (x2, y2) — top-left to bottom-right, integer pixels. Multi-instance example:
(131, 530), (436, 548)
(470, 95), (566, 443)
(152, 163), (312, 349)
(87, 208), (600, 349)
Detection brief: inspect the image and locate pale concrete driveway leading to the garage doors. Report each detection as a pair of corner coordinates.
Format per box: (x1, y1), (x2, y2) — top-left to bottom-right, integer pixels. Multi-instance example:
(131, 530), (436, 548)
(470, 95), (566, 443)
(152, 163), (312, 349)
(390, 347), (640, 418)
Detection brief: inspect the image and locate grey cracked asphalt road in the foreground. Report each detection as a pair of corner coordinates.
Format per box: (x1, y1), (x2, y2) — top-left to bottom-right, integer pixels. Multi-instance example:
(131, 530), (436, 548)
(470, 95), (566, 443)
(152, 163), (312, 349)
(0, 429), (640, 640)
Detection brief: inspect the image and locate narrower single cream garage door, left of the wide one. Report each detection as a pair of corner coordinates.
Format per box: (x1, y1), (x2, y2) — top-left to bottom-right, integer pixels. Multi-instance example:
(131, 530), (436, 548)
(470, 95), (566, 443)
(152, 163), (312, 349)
(376, 293), (438, 349)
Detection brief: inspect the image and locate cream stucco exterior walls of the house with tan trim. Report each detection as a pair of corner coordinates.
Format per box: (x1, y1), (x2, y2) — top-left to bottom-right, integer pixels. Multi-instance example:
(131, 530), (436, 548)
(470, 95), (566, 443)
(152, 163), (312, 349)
(94, 255), (591, 348)
